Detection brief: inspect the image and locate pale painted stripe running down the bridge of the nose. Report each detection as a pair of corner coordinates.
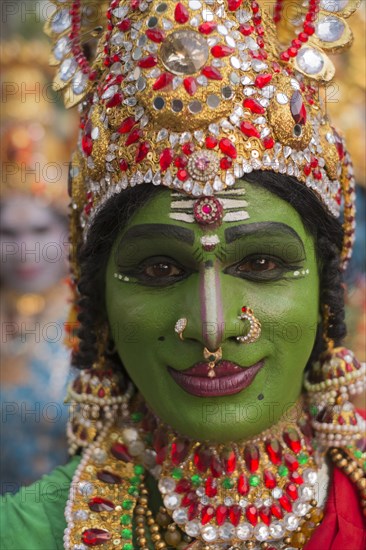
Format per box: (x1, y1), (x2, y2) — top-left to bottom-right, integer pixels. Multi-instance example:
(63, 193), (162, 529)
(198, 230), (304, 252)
(199, 259), (224, 351)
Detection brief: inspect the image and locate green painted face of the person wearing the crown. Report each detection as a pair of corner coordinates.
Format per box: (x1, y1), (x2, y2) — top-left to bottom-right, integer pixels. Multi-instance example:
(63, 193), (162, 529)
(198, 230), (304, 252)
(106, 183), (319, 442)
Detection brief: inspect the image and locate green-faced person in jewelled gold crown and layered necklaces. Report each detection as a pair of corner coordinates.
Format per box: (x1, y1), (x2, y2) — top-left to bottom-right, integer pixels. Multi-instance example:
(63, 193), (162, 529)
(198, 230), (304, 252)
(4, 0), (366, 550)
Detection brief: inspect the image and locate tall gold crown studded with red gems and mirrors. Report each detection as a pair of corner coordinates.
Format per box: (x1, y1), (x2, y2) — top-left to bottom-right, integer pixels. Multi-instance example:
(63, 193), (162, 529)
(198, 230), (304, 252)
(46, 0), (360, 265)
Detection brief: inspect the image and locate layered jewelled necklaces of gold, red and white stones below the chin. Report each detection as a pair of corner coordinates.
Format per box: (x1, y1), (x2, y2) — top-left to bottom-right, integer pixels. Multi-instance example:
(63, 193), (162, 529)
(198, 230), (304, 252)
(64, 404), (323, 550)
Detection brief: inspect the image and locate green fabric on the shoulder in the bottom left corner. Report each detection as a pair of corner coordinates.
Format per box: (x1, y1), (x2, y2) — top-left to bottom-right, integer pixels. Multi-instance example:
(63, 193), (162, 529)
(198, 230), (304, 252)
(0, 457), (80, 550)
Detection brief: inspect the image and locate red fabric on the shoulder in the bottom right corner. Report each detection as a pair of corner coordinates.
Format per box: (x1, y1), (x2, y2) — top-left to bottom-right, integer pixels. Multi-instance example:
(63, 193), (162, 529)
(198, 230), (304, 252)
(304, 468), (366, 550)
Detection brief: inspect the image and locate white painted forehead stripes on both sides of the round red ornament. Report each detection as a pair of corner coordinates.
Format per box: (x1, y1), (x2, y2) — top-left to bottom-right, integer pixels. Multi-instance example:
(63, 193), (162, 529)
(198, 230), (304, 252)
(169, 189), (250, 223)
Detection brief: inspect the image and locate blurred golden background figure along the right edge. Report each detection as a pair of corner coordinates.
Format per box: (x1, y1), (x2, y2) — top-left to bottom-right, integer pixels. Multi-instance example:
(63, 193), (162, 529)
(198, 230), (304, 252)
(325, 8), (366, 370)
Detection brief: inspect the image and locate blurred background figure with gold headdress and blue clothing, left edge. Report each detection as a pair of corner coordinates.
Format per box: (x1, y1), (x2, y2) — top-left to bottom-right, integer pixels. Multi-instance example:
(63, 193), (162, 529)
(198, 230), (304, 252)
(0, 40), (73, 492)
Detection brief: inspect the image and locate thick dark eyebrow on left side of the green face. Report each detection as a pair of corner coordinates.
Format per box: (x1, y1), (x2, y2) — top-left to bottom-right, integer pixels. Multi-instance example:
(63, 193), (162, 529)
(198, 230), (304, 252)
(119, 223), (195, 246)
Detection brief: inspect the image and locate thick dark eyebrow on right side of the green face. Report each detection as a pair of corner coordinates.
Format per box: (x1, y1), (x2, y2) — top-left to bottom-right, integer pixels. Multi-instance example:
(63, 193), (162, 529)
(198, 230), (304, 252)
(225, 222), (305, 251)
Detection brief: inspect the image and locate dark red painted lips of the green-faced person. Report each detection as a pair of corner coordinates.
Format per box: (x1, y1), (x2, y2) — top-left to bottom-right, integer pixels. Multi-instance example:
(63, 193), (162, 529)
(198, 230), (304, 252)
(168, 360), (264, 397)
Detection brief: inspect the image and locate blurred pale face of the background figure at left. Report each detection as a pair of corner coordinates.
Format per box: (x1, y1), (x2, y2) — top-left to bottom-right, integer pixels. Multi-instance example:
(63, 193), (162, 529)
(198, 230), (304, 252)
(0, 195), (67, 293)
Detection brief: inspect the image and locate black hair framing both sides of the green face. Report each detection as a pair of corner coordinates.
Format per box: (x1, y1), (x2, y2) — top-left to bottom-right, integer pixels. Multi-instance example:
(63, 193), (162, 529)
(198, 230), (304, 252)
(73, 171), (346, 376)
